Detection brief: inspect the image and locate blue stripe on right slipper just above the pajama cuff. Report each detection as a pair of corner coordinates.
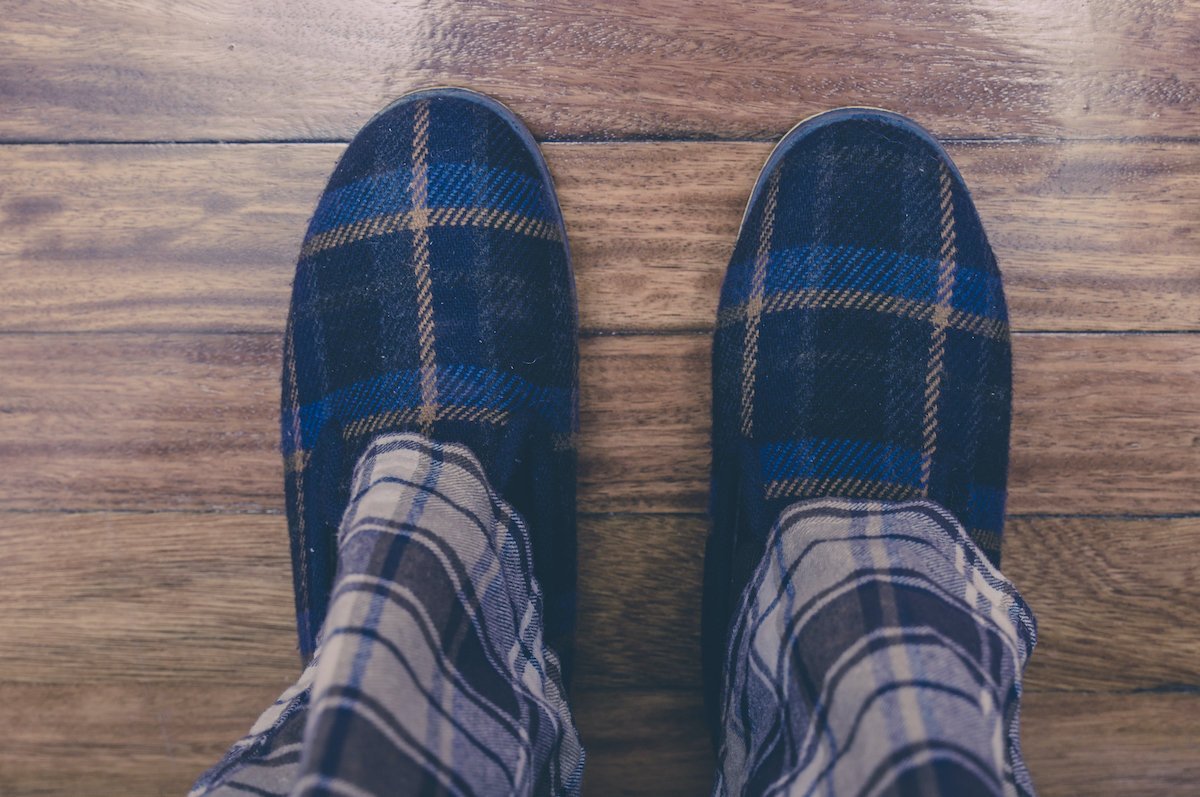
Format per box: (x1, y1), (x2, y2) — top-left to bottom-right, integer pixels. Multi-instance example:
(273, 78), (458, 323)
(761, 438), (920, 487)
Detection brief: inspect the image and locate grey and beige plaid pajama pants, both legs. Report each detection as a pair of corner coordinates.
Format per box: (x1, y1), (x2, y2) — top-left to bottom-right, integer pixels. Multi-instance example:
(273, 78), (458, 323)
(191, 435), (1036, 797)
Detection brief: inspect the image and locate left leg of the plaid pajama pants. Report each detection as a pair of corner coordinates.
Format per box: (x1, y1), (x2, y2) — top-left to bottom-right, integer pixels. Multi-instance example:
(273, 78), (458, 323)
(191, 433), (584, 797)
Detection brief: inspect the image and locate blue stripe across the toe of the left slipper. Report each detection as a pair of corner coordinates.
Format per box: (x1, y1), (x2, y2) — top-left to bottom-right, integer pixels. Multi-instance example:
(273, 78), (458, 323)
(306, 163), (551, 240)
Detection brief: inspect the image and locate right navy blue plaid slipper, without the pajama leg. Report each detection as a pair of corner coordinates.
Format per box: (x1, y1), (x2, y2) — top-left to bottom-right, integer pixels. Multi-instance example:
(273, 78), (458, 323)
(702, 108), (1012, 729)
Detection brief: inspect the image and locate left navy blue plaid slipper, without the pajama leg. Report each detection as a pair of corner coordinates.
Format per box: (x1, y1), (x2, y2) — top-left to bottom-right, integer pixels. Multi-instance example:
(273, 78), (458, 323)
(281, 89), (578, 675)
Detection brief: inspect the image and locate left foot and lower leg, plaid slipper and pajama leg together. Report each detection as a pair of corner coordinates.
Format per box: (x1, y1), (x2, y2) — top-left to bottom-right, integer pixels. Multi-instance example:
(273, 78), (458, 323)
(197, 89), (582, 793)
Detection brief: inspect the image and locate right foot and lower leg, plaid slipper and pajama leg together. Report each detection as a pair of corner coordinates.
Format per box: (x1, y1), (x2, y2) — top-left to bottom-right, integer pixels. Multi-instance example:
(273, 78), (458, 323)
(703, 108), (1033, 795)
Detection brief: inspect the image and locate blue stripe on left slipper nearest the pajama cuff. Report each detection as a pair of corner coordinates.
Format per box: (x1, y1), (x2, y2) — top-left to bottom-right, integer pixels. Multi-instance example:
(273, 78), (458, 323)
(283, 365), (574, 455)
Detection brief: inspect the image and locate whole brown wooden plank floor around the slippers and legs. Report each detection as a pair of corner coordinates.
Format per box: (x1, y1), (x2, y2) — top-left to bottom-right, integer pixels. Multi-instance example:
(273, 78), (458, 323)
(0, 0), (1200, 797)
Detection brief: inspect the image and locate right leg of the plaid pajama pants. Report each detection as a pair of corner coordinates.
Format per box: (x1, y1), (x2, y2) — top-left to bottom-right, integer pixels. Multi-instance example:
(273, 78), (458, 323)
(713, 498), (1037, 797)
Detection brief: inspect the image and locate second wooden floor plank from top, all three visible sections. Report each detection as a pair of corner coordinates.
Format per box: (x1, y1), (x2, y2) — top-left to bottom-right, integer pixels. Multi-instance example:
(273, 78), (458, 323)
(0, 142), (1200, 331)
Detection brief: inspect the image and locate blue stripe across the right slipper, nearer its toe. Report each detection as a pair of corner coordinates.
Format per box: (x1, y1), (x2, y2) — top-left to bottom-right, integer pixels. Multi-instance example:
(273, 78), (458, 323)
(722, 246), (1003, 318)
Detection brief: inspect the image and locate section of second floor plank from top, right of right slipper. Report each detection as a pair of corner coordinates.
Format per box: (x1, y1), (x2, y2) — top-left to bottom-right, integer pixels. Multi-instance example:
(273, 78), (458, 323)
(948, 143), (1200, 331)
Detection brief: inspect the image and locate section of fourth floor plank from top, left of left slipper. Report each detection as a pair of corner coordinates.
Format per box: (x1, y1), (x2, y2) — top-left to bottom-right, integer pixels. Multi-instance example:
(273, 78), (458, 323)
(0, 513), (300, 681)
